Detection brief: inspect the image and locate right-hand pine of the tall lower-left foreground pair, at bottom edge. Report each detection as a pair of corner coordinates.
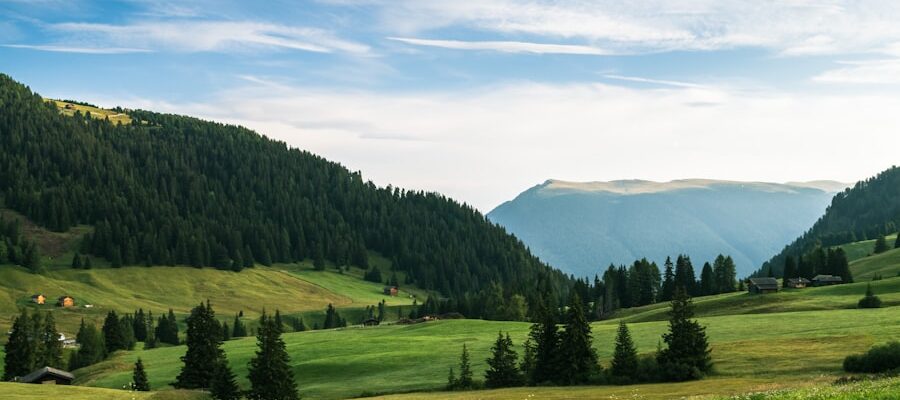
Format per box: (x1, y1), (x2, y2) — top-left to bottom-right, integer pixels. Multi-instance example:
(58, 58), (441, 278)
(247, 313), (300, 400)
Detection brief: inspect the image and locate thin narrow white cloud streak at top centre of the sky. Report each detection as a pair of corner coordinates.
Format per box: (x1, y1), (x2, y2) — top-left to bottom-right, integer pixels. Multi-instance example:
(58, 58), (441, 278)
(388, 37), (612, 55)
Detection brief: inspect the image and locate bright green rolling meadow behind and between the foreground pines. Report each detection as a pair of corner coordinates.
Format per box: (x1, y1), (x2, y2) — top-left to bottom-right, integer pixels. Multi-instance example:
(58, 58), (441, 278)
(78, 307), (900, 398)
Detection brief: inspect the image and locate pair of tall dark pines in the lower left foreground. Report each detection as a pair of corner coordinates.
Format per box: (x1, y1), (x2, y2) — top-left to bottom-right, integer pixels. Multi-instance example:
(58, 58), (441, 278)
(173, 301), (299, 400)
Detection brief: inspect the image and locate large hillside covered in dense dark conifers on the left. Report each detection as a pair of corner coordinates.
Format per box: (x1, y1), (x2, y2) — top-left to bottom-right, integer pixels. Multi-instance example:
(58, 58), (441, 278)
(0, 75), (571, 318)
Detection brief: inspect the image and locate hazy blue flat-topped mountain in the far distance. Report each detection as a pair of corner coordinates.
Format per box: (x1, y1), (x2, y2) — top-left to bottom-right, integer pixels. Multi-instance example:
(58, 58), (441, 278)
(488, 179), (847, 276)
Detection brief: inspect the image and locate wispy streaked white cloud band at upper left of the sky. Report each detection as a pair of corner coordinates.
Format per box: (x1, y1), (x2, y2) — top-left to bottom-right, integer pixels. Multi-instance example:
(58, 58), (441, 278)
(42, 20), (369, 54)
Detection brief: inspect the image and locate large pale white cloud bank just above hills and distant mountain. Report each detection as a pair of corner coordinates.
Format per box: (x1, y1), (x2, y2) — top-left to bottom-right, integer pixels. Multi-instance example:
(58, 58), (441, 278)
(106, 77), (900, 211)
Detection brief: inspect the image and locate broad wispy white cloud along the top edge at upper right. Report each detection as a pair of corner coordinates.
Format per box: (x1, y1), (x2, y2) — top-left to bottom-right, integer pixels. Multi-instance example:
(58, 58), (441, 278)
(337, 0), (900, 55)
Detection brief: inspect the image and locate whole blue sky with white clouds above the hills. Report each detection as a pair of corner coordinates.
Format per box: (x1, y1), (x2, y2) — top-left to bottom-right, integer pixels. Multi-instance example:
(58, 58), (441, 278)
(0, 0), (900, 212)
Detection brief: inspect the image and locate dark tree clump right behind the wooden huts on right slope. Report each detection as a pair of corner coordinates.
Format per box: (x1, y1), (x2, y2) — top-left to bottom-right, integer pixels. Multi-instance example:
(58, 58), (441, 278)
(776, 246), (853, 287)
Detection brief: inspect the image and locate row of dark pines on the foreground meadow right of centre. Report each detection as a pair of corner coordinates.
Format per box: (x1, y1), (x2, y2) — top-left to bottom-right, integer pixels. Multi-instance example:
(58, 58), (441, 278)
(447, 286), (712, 390)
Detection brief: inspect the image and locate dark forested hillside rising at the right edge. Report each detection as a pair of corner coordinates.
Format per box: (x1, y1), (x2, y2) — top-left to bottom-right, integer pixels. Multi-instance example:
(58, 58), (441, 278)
(760, 166), (900, 276)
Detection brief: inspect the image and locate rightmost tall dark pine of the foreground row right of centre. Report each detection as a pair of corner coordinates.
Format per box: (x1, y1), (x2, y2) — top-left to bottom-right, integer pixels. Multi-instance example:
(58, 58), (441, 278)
(657, 290), (712, 381)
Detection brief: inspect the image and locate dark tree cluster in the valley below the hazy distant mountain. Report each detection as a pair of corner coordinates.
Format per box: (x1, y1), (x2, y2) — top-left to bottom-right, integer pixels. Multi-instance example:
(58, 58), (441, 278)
(572, 254), (737, 320)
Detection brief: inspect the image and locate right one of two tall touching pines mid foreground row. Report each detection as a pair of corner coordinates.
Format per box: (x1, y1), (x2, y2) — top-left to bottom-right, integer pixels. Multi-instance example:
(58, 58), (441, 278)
(557, 293), (598, 385)
